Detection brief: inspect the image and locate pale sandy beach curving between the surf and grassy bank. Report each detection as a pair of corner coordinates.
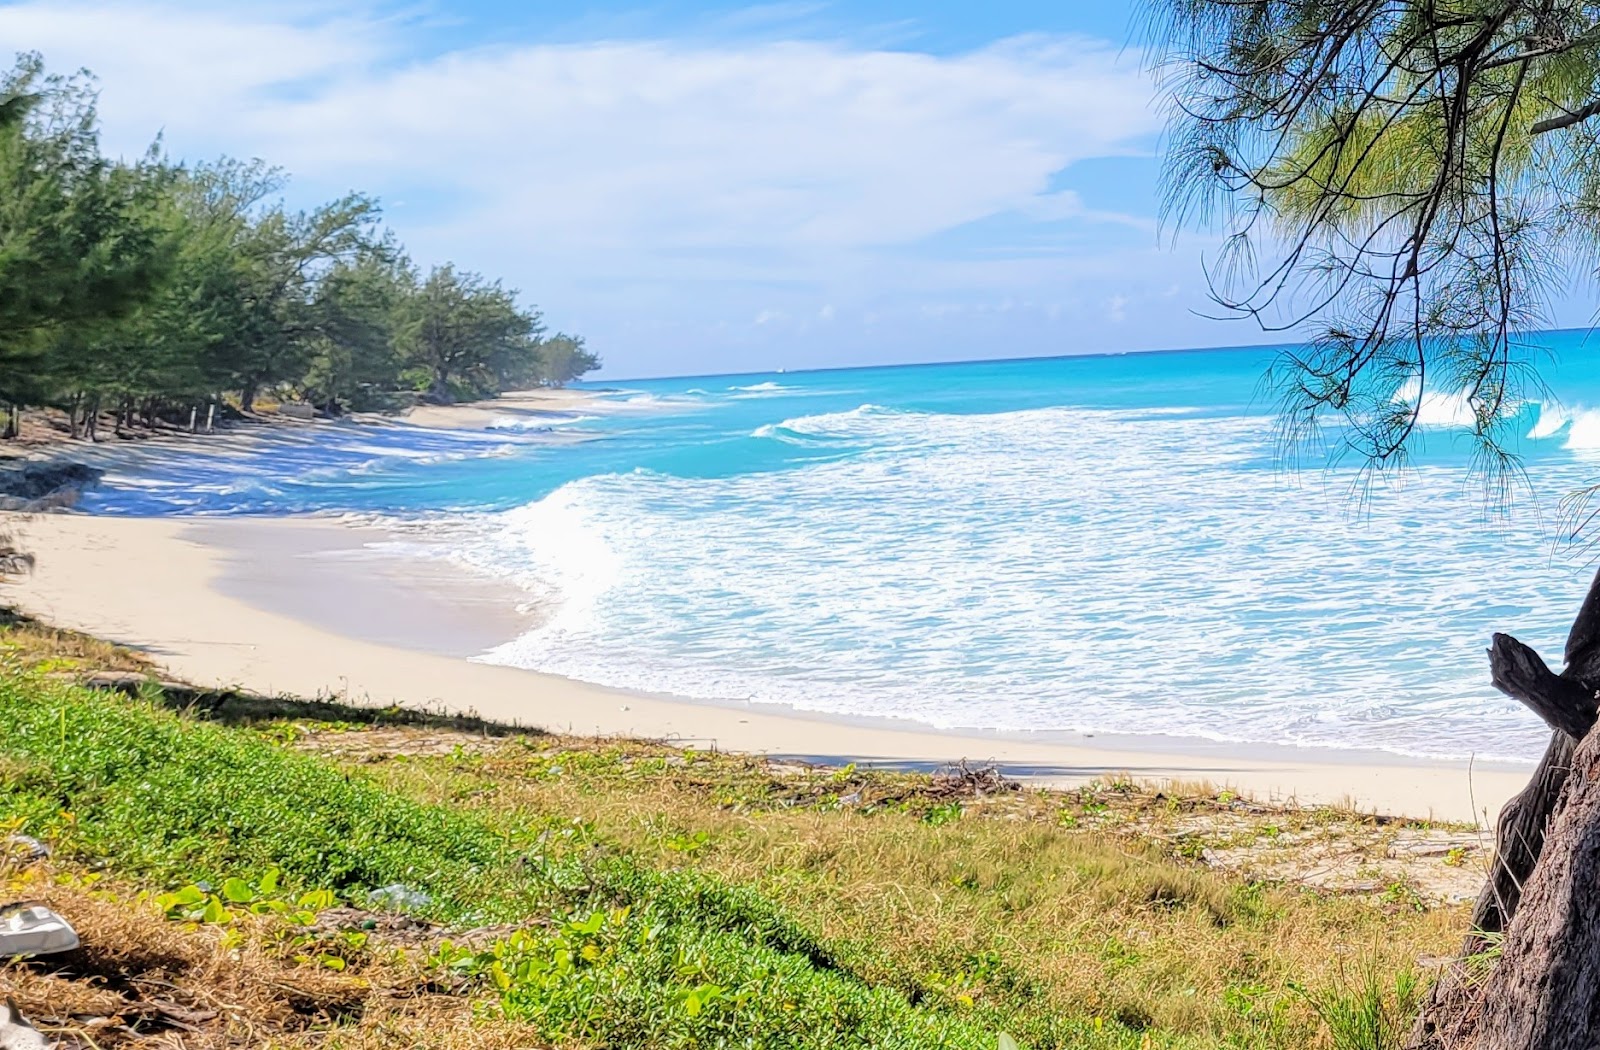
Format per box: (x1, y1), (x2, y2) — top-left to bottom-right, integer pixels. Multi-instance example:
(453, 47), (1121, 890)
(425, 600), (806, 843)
(0, 515), (1528, 821)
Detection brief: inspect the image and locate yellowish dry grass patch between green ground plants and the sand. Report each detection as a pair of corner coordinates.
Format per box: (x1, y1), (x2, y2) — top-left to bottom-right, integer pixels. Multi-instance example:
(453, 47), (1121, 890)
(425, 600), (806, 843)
(321, 730), (1480, 1045)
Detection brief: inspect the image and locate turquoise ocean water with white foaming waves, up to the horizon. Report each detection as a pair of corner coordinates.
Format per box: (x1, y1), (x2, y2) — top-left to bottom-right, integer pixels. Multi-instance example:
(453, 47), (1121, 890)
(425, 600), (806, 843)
(86, 333), (1600, 759)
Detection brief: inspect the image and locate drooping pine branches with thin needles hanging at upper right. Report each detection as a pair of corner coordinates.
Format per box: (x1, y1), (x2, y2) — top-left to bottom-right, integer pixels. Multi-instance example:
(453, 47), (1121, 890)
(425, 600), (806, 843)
(1144, 0), (1600, 482)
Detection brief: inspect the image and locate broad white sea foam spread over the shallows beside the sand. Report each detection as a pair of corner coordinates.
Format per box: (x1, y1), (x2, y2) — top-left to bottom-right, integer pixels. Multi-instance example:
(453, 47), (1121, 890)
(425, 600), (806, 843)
(474, 403), (1587, 757)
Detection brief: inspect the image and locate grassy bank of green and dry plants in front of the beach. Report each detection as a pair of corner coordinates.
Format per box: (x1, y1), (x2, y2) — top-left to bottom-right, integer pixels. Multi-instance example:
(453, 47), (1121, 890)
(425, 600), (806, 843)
(0, 623), (1464, 1050)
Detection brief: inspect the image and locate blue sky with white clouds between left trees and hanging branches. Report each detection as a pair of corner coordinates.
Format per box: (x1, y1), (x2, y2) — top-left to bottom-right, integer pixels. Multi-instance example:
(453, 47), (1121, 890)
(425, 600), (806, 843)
(0, 0), (1587, 378)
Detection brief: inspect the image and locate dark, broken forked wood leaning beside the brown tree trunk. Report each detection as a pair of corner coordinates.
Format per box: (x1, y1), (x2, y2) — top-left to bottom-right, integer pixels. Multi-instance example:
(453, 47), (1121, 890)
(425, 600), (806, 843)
(1406, 573), (1600, 1050)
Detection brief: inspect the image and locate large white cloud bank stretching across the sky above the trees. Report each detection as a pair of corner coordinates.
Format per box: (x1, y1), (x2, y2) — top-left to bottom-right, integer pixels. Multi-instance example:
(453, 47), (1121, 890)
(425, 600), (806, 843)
(0, 0), (1177, 372)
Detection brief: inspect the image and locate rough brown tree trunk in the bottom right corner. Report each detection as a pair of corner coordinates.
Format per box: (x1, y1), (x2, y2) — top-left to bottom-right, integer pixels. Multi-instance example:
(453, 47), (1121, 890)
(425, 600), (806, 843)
(1470, 733), (1600, 1050)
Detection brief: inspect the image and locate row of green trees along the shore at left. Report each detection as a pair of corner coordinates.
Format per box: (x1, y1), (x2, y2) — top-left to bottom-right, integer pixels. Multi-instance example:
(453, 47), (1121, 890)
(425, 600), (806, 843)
(0, 54), (600, 437)
